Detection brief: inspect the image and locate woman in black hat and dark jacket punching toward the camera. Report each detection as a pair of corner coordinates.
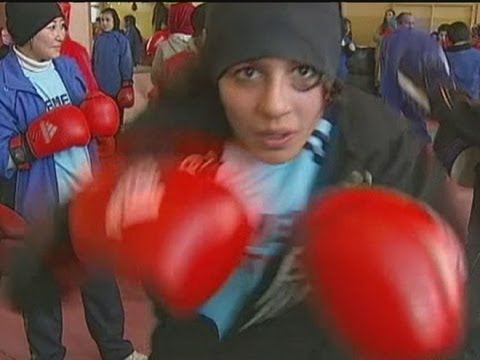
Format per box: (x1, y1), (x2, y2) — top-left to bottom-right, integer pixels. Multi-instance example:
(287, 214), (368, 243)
(118, 3), (463, 360)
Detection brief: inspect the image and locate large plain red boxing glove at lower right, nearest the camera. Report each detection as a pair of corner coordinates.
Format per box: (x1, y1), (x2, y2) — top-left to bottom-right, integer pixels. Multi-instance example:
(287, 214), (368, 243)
(302, 188), (466, 360)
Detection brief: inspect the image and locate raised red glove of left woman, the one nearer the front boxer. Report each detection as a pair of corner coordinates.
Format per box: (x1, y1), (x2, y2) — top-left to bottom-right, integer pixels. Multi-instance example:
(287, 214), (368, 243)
(80, 91), (120, 137)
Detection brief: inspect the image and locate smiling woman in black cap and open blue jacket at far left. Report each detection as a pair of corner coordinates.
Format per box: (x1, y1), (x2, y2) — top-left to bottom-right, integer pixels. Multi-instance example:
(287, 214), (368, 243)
(0, 3), (143, 360)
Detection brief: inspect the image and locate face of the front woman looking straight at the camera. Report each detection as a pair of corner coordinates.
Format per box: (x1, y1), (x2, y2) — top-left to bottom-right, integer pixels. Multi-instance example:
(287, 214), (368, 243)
(219, 58), (325, 164)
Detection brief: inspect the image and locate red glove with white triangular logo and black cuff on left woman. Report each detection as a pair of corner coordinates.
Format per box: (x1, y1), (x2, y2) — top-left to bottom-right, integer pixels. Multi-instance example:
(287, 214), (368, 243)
(10, 105), (90, 170)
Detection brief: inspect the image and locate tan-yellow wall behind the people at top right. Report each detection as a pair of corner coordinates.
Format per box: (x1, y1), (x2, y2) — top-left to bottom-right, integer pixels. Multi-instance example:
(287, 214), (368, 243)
(342, 2), (480, 46)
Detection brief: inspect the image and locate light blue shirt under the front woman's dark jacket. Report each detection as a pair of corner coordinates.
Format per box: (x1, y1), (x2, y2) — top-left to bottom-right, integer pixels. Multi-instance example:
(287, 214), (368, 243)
(199, 119), (332, 338)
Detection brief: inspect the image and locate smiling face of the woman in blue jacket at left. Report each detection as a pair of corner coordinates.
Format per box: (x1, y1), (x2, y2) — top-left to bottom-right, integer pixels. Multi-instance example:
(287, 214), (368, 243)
(22, 17), (66, 61)
